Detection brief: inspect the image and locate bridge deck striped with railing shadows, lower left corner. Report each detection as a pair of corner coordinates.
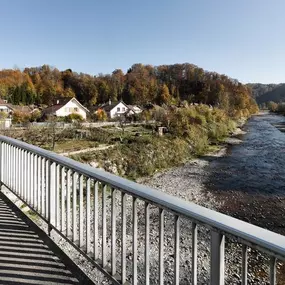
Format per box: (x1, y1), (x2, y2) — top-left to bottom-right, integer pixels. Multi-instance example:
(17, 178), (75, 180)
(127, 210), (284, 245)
(0, 193), (84, 285)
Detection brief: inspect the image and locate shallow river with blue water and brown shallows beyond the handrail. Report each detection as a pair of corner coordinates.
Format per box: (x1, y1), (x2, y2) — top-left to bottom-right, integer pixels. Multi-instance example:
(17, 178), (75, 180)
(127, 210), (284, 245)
(204, 113), (285, 234)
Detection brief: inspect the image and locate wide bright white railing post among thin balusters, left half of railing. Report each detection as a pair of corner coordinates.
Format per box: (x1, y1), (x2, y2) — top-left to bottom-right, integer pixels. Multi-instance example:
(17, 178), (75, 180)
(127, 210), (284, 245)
(47, 161), (56, 235)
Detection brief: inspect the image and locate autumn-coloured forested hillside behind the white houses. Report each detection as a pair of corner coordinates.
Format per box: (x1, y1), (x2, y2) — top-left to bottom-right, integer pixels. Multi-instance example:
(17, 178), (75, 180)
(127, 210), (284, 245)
(0, 63), (256, 113)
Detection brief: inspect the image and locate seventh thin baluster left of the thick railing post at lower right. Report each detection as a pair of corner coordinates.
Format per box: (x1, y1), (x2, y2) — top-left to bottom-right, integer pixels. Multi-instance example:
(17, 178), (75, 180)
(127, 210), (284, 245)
(111, 187), (117, 276)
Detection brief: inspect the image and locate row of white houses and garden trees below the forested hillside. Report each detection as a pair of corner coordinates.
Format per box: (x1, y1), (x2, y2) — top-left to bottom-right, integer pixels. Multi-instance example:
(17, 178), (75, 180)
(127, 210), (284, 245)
(0, 97), (144, 129)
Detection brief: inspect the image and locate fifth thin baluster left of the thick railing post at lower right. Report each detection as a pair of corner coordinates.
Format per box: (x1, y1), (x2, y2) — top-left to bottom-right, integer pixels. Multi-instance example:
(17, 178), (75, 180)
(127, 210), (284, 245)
(132, 197), (138, 285)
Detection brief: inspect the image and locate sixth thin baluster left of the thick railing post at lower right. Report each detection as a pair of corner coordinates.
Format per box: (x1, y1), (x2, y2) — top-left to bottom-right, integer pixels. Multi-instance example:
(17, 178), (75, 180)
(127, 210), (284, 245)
(121, 192), (127, 284)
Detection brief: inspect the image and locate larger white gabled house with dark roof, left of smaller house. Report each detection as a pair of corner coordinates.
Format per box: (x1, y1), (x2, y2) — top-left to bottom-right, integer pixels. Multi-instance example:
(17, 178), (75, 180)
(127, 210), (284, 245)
(43, 97), (89, 120)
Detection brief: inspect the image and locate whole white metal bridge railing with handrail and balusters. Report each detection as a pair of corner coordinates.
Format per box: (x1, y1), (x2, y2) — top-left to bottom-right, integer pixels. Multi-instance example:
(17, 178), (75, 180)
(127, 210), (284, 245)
(0, 136), (285, 285)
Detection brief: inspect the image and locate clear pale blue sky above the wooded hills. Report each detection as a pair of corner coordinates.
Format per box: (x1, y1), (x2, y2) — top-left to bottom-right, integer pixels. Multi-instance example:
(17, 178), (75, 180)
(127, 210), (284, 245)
(0, 0), (285, 83)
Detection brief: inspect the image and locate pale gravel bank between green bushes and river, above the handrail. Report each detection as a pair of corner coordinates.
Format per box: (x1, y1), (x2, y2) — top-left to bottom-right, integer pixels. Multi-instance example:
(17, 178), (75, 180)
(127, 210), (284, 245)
(137, 123), (246, 210)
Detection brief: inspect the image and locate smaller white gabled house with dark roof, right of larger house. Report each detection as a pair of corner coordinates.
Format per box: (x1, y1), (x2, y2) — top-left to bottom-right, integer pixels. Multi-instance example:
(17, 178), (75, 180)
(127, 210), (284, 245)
(97, 101), (142, 119)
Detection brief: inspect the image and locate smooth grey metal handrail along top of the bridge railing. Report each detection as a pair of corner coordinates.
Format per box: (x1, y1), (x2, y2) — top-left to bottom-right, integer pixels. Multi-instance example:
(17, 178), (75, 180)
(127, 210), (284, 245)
(0, 135), (285, 259)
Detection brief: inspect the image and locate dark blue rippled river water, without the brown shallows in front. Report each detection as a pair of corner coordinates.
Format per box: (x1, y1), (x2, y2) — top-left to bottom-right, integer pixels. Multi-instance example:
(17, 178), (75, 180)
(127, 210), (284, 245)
(207, 114), (285, 196)
